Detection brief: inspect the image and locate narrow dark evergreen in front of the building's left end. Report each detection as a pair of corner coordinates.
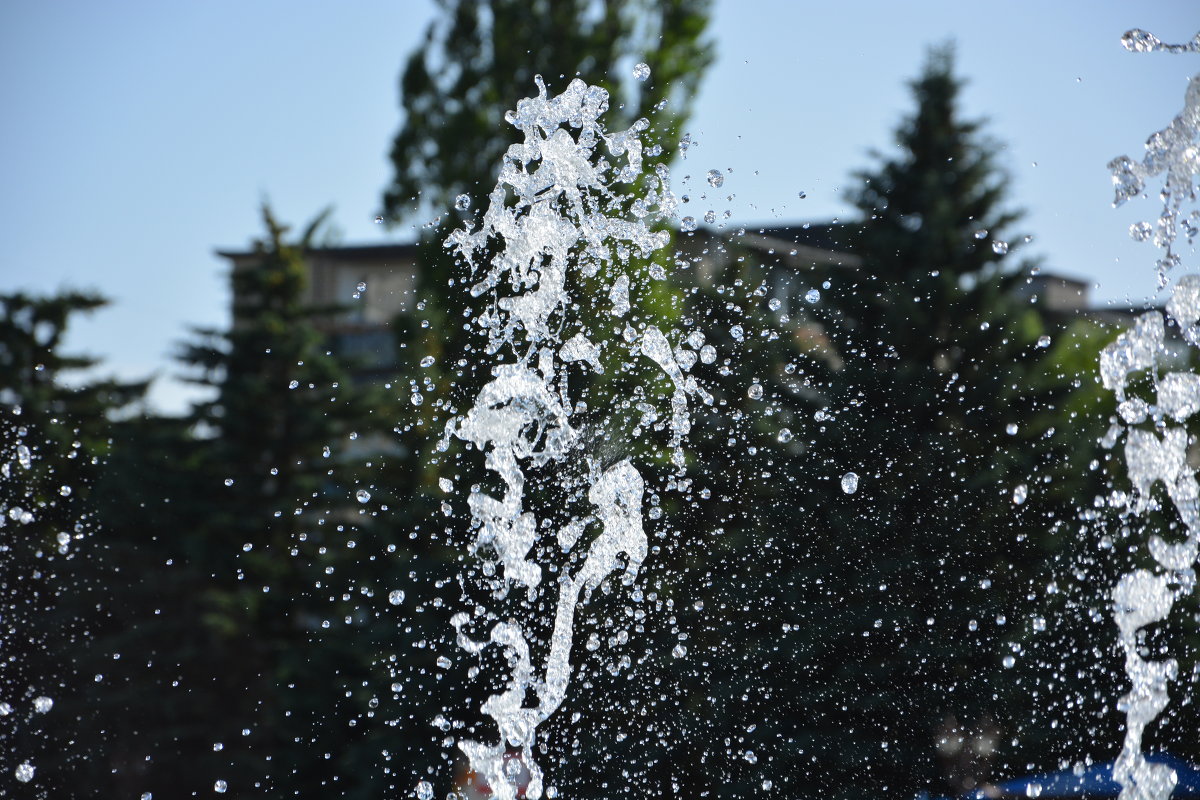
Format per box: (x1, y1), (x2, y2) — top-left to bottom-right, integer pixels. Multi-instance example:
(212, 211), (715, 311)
(164, 206), (403, 793)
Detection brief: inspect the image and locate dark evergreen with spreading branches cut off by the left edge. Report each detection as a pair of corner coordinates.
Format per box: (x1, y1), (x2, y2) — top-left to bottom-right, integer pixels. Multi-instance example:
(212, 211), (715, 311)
(0, 291), (148, 796)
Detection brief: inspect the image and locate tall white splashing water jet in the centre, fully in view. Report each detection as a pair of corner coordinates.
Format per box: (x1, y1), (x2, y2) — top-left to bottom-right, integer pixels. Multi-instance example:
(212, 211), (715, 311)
(439, 78), (710, 800)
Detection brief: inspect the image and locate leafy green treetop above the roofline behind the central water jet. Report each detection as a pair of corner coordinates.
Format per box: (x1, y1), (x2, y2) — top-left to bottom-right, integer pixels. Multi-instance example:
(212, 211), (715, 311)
(383, 0), (712, 222)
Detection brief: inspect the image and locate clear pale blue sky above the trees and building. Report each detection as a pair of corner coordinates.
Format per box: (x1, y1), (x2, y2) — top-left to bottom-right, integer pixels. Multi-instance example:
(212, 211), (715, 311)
(0, 0), (1200, 411)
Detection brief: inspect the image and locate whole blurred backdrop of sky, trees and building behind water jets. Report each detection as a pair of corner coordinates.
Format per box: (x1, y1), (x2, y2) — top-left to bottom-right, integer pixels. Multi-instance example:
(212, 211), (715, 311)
(0, 0), (1200, 800)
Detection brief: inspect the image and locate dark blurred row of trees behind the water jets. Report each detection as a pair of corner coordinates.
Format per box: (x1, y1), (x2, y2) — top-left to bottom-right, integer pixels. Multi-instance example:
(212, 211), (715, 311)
(0, 0), (1200, 799)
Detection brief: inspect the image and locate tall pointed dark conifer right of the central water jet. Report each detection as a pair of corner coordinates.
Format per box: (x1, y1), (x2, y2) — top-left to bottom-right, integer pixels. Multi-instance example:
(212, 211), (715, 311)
(793, 47), (1103, 794)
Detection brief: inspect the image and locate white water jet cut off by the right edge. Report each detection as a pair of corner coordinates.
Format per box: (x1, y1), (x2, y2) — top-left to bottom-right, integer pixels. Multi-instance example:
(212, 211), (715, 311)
(1100, 30), (1200, 800)
